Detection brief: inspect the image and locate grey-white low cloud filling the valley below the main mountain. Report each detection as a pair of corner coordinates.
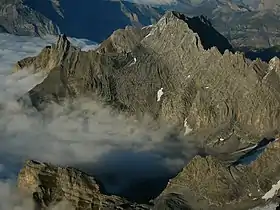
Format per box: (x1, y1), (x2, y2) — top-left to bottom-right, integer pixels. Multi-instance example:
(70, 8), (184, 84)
(0, 34), (195, 210)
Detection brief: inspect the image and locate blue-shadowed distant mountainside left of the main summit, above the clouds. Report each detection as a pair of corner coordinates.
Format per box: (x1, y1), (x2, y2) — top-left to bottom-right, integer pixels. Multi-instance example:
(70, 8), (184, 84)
(0, 0), (164, 42)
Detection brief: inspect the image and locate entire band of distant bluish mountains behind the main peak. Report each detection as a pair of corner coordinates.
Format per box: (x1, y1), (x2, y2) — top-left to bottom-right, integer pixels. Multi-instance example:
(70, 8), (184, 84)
(0, 0), (280, 48)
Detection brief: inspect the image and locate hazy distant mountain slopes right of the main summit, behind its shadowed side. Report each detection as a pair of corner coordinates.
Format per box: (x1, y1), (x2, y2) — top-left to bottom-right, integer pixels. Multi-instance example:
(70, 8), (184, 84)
(168, 0), (280, 48)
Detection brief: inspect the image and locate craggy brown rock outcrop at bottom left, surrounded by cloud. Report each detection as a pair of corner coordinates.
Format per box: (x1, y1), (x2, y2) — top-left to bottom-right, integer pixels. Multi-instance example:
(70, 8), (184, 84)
(18, 161), (149, 210)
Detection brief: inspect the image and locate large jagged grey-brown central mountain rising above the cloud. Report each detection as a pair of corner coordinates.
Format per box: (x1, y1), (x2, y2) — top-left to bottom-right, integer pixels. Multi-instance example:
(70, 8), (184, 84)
(15, 12), (280, 148)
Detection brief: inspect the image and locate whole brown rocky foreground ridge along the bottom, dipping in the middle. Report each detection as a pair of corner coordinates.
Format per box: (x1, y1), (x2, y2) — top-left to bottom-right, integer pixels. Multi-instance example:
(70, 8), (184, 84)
(18, 139), (280, 210)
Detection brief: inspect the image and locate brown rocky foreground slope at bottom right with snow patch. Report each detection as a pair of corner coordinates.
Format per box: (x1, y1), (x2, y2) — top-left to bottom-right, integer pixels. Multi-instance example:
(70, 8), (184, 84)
(155, 141), (280, 210)
